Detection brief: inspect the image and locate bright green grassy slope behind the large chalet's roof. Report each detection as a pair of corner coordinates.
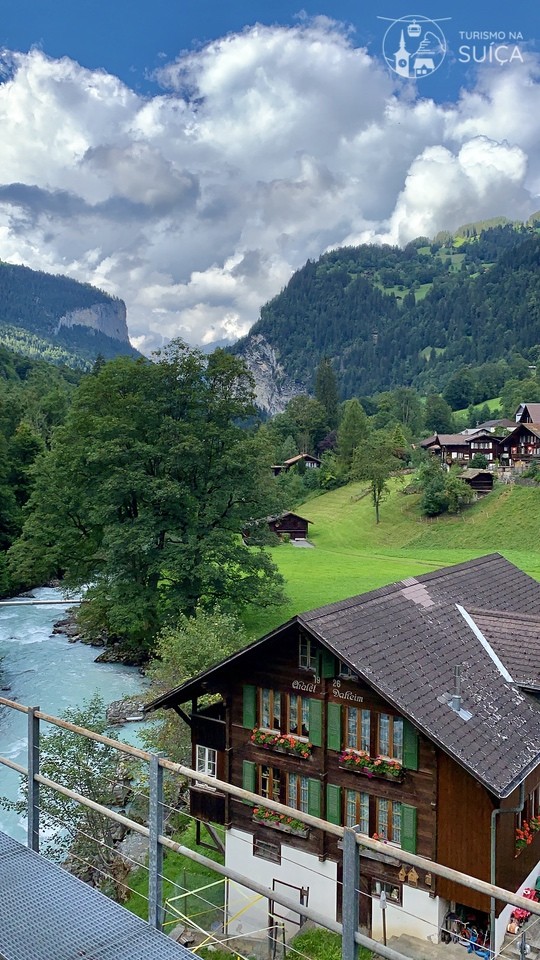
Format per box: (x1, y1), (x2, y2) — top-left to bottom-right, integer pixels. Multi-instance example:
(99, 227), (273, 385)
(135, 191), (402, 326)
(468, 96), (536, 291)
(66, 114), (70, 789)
(246, 481), (540, 636)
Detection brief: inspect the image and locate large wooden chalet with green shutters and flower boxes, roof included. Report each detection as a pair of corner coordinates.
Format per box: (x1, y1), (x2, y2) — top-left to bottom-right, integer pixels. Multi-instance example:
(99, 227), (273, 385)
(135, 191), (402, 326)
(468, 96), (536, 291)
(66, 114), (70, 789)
(147, 554), (540, 951)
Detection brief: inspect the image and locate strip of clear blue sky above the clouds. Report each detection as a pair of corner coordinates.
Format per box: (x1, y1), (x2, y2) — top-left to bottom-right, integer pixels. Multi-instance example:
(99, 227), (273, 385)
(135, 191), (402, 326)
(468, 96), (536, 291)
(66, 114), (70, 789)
(0, 0), (540, 100)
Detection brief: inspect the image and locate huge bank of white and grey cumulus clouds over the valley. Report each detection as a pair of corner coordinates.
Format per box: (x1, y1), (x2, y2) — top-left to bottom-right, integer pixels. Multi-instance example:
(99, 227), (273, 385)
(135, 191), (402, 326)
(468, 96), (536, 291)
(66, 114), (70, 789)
(0, 26), (540, 350)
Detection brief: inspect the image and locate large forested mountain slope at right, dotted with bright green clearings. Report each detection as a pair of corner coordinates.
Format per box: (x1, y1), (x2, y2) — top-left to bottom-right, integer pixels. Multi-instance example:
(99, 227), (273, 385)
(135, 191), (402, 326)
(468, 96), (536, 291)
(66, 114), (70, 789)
(234, 221), (540, 398)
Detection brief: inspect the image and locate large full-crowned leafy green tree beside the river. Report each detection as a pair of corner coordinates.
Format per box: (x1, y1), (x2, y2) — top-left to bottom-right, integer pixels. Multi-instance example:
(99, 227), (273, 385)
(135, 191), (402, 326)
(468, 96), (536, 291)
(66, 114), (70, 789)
(12, 343), (282, 654)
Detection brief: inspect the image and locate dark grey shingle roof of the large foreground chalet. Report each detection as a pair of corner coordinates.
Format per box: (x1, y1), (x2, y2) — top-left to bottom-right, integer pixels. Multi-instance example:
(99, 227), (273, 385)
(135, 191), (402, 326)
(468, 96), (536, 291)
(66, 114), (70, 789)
(149, 554), (540, 797)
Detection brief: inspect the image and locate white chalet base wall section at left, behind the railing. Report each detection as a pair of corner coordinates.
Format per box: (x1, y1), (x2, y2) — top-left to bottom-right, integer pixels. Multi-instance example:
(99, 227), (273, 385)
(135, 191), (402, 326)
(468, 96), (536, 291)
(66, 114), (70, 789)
(225, 829), (337, 937)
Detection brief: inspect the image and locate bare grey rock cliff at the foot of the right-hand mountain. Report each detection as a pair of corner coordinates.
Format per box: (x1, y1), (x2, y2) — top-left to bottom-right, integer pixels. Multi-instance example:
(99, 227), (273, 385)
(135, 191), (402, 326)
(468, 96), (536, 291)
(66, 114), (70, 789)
(240, 334), (305, 416)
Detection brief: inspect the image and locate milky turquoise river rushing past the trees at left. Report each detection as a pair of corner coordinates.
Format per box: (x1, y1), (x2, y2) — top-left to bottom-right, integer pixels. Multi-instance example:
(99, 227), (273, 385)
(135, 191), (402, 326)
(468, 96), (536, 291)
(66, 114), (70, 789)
(0, 587), (148, 843)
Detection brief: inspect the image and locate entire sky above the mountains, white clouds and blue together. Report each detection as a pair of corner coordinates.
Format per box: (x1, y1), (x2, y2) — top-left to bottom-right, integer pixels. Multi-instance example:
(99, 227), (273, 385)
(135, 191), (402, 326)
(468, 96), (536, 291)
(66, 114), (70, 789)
(0, 0), (540, 351)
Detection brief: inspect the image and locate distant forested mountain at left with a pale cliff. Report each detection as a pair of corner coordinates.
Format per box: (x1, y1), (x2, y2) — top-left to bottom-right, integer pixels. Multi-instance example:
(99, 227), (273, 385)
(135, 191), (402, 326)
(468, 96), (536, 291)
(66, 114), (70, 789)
(0, 261), (138, 368)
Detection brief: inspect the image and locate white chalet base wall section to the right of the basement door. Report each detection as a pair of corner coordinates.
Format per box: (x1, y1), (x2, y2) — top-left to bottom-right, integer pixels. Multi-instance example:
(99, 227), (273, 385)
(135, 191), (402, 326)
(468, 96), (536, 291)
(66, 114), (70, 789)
(371, 884), (448, 943)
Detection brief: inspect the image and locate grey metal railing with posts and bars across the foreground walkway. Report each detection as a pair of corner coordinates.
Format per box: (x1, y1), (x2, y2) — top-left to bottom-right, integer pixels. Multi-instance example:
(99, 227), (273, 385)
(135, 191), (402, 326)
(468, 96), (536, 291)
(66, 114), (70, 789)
(0, 697), (540, 960)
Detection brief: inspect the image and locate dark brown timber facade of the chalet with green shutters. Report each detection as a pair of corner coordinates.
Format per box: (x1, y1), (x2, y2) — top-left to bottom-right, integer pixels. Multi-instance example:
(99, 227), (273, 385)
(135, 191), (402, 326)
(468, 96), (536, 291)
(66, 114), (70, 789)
(179, 627), (540, 920)
